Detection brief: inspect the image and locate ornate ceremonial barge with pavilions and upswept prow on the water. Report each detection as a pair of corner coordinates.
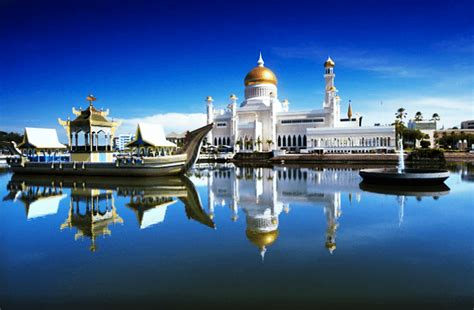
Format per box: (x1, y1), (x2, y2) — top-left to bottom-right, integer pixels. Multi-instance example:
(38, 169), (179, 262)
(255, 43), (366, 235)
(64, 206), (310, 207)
(8, 95), (213, 176)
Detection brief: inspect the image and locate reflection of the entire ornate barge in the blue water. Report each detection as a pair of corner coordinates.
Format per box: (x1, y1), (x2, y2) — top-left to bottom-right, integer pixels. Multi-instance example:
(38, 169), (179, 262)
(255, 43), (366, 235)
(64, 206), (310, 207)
(3, 175), (215, 251)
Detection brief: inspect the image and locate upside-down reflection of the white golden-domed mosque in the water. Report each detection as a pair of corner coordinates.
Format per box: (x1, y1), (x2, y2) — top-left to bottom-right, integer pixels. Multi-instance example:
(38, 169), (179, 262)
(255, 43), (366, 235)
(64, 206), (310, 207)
(202, 167), (360, 258)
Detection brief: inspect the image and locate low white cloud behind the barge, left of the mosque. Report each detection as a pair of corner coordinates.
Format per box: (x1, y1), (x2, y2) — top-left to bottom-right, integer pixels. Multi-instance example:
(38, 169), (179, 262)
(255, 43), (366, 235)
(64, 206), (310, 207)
(117, 113), (206, 134)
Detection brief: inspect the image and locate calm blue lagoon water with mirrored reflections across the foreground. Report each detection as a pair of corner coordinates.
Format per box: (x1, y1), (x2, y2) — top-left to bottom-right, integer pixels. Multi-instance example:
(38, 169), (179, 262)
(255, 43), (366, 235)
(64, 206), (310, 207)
(0, 165), (474, 310)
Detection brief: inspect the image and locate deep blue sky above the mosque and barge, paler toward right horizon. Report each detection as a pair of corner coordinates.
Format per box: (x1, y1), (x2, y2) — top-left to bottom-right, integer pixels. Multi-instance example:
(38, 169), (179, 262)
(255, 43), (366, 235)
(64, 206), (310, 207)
(0, 0), (474, 136)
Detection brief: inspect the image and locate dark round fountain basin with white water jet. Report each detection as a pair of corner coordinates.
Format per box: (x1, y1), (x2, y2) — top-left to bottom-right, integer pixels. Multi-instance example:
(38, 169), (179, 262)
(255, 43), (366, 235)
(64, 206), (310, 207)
(359, 138), (449, 185)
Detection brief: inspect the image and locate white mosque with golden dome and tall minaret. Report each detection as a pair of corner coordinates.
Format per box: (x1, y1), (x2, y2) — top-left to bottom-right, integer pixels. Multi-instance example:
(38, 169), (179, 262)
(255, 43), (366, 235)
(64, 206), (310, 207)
(206, 54), (396, 153)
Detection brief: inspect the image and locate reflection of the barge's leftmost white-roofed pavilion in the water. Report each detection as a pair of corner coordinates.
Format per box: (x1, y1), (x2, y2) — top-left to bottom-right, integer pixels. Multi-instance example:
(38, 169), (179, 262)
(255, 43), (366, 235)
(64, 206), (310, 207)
(3, 178), (67, 220)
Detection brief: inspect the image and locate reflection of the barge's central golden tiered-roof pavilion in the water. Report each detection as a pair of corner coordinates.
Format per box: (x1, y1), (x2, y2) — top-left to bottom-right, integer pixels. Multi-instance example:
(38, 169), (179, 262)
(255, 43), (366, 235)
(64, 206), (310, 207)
(61, 188), (123, 251)
